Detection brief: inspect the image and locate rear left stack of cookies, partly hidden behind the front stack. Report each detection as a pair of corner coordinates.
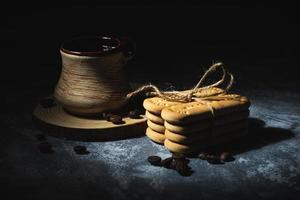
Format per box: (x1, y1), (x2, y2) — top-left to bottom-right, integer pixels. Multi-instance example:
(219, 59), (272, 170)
(143, 97), (181, 144)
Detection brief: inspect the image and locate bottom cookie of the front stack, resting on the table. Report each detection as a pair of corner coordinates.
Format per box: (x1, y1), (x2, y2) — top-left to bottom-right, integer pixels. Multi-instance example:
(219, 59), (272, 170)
(164, 129), (247, 154)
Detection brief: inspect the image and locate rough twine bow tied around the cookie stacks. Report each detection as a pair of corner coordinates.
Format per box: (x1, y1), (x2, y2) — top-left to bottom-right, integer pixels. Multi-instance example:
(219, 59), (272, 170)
(126, 62), (240, 114)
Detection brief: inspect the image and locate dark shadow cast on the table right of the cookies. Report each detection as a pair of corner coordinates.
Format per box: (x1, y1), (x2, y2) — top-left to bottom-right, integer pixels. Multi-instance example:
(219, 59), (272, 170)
(205, 118), (294, 155)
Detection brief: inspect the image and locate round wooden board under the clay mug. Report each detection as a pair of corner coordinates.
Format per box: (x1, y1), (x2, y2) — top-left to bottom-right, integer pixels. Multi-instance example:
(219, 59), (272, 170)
(33, 105), (147, 141)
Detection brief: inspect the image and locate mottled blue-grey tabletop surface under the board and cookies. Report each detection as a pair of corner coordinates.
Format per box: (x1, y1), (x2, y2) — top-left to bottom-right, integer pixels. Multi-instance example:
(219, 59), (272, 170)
(0, 58), (300, 200)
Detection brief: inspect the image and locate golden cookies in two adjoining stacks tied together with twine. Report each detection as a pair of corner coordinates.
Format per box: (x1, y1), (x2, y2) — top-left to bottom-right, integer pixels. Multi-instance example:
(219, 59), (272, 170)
(144, 88), (250, 153)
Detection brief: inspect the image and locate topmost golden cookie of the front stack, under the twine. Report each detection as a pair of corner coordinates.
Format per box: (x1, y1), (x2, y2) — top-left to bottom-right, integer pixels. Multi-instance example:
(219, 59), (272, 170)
(161, 95), (250, 124)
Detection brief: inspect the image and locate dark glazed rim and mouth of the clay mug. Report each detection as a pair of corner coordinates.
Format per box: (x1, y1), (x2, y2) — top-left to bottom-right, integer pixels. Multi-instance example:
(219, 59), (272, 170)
(60, 36), (125, 56)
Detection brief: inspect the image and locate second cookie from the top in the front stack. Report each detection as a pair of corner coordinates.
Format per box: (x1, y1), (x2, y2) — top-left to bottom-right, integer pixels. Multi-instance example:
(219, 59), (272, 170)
(164, 110), (249, 134)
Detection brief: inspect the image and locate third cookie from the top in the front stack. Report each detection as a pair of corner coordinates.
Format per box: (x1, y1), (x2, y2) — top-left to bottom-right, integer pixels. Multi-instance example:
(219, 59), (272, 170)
(165, 120), (248, 144)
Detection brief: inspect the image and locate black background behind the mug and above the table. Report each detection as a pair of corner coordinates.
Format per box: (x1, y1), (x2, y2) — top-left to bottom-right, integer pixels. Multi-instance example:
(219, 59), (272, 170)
(0, 0), (300, 88)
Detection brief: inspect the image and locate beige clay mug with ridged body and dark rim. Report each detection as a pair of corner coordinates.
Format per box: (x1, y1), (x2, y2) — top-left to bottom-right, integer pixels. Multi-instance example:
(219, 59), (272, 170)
(54, 36), (134, 115)
